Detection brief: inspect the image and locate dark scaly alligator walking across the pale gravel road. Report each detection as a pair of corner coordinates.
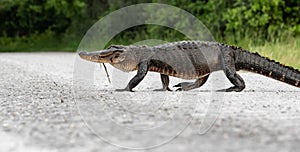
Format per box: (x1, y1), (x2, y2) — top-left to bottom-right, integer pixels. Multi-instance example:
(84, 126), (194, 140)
(78, 41), (300, 92)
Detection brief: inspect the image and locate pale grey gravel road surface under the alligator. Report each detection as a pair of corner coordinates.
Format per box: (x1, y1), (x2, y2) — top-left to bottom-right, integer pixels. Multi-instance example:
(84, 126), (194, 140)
(0, 53), (300, 152)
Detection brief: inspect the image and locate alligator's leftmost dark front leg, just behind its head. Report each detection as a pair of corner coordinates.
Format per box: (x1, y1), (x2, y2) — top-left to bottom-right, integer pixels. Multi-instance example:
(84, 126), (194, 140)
(116, 61), (149, 92)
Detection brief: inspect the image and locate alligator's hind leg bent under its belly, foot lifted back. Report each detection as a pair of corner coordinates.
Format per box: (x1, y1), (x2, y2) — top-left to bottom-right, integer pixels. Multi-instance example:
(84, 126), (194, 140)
(173, 75), (209, 91)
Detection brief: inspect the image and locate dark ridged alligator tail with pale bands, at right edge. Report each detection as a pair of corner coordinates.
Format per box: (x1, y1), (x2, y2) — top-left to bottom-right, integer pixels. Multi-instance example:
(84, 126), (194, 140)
(235, 49), (300, 88)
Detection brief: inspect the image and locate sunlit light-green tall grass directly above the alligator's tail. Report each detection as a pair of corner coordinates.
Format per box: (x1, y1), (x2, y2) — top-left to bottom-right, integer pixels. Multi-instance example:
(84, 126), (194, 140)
(219, 31), (300, 69)
